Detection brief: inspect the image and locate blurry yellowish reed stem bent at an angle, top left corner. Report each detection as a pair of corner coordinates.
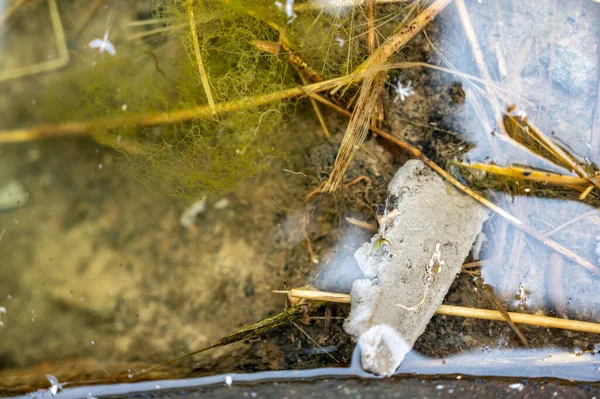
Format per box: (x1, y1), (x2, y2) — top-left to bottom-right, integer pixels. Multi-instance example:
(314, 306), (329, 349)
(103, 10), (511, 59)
(0, 0), (70, 82)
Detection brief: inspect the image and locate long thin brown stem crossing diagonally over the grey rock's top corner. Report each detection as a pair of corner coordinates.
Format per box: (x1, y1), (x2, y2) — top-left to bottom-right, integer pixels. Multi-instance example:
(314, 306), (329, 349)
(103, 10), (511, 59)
(305, 89), (600, 274)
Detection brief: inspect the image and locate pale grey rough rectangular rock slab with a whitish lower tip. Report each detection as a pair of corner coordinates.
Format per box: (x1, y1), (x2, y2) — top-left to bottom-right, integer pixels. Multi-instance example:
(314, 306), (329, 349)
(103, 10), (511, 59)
(344, 160), (488, 375)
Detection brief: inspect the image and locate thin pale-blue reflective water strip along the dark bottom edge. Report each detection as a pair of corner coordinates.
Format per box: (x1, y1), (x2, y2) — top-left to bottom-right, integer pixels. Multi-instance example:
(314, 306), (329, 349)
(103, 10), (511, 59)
(10, 348), (600, 398)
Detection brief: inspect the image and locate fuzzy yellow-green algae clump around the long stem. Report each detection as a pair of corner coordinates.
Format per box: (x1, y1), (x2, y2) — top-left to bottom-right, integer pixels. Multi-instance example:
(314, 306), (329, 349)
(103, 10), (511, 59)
(42, 0), (418, 199)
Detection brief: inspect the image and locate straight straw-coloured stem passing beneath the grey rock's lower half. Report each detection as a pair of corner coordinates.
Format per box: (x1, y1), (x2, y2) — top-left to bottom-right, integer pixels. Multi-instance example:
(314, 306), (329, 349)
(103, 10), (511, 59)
(282, 288), (600, 334)
